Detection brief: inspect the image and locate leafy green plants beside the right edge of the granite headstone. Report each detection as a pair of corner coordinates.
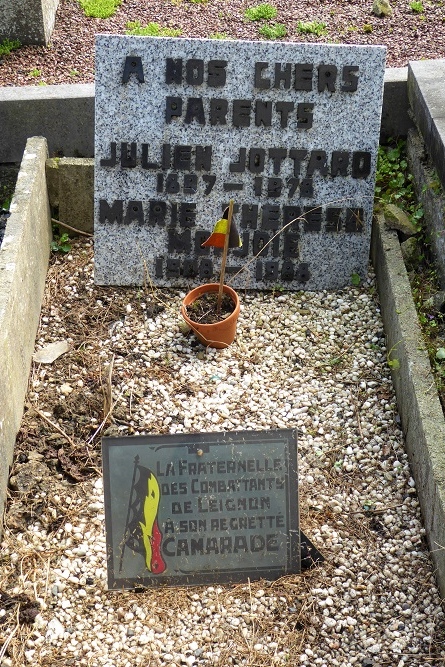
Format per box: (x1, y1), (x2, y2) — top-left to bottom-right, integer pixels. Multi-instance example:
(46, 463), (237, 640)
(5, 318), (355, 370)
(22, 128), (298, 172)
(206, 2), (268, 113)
(375, 140), (423, 230)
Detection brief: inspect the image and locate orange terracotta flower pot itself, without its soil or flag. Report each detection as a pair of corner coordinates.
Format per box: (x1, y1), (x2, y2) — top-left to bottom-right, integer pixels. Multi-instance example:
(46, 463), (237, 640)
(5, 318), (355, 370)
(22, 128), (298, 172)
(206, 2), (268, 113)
(181, 283), (240, 348)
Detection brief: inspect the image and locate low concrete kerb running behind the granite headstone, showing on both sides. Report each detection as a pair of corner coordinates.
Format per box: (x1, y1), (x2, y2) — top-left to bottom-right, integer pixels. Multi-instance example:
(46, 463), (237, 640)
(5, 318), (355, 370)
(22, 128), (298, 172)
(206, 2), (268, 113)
(0, 69), (406, 164)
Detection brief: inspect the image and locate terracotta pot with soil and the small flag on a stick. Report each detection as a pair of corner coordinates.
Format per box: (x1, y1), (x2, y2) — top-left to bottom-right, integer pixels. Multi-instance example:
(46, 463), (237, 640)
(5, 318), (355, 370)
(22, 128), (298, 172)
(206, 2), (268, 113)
(181, 199), (241, 348)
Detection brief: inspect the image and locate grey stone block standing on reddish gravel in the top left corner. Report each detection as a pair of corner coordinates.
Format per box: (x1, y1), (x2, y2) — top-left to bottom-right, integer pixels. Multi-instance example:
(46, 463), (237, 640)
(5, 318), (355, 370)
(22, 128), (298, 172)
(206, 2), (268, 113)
(0, 0), (59, 44)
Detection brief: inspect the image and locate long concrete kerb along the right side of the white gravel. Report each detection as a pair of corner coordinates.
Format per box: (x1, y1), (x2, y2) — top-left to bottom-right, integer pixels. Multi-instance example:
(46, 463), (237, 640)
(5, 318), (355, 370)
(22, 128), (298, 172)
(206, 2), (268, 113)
(372, 218), (445, 597)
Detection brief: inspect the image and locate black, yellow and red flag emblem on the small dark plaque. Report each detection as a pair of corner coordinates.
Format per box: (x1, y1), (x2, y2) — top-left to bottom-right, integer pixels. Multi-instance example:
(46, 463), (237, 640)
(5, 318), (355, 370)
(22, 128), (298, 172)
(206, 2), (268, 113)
(121, 461), (166, 574)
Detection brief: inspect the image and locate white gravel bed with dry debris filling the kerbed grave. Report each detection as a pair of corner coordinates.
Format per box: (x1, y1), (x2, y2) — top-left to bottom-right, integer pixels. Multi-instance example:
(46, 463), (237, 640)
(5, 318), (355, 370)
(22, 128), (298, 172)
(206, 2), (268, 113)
(0, 241), (445, 667)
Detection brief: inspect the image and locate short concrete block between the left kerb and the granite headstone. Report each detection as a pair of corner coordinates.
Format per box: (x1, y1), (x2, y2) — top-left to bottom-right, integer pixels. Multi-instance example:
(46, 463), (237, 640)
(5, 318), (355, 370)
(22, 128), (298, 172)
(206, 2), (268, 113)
(46, 158), (94, 233)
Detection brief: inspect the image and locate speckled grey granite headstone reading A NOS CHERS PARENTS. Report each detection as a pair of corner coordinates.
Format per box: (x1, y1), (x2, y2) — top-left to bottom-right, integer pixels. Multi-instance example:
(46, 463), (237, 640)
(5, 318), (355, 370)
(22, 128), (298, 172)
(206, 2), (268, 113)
(95, 35), (385, 290)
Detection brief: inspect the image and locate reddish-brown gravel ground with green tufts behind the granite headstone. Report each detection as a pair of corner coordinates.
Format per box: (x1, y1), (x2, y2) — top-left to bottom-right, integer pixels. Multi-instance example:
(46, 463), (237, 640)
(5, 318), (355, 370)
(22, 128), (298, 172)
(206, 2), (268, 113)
(0, 0), (445, 86)
